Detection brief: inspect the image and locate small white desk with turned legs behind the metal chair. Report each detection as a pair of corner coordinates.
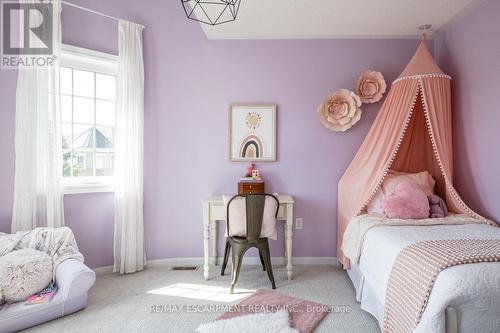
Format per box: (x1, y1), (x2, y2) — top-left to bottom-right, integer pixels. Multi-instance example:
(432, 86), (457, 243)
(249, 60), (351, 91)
(203, 194), (294, 280)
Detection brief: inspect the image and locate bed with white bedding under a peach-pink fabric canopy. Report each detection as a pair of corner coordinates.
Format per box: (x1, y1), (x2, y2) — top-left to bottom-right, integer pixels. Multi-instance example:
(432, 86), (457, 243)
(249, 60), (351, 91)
(337, 35), (500, 333)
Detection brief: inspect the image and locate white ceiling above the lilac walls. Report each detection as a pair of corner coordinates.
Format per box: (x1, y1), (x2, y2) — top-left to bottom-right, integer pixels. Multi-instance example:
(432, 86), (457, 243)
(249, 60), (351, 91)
(195, 0), (478, 39)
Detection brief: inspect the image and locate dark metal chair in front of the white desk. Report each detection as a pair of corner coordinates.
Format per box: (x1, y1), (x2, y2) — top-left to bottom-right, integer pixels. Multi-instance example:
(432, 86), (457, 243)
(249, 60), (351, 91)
(221, 193), (279, 294)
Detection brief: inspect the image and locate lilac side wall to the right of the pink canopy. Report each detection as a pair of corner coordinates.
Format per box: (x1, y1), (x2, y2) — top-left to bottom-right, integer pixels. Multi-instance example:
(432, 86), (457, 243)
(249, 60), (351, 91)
(435, 0), (500, 222)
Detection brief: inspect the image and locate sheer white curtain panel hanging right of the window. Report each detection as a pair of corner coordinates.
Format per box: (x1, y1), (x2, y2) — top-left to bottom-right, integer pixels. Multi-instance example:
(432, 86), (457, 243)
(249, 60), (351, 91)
(114, 20), (146, 274)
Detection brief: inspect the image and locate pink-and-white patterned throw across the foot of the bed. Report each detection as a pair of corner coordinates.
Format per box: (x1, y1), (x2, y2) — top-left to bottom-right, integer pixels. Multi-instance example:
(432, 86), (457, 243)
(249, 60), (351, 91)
(383, 239), (500, 333)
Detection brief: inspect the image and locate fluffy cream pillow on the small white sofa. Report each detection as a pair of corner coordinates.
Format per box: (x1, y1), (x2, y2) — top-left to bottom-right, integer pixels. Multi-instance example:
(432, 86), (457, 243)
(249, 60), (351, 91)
(0, 249), (53, 304)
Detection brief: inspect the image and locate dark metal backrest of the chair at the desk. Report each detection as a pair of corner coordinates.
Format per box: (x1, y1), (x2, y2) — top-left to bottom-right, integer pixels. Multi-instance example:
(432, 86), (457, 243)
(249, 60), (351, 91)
(226, 193), (279, 242)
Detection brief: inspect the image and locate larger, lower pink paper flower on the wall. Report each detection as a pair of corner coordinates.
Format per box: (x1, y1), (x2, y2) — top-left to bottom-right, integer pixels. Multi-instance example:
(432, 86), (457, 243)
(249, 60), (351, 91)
(318, 89), (361, 132)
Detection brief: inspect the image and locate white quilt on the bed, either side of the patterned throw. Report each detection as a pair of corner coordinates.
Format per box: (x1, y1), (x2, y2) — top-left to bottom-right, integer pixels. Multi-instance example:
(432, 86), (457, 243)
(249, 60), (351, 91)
(350, 218), (500, 333)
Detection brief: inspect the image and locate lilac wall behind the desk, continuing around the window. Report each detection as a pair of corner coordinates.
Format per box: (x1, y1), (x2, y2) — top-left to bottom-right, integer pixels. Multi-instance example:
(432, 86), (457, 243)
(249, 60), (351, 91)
(0, 0), (418, 266)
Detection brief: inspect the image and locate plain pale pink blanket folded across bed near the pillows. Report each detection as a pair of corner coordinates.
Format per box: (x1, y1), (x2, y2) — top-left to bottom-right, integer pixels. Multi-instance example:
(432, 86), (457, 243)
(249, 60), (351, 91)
(342, 214), (497, 269)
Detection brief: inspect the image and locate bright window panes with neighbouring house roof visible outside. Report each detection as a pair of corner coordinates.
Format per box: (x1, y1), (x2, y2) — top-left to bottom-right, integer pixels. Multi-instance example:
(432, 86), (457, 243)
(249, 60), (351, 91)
(60, 66), (116, 177)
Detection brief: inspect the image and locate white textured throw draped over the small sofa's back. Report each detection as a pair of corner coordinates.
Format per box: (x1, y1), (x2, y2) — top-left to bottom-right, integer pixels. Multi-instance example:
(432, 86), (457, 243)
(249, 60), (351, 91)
(0, 227), (83, 272)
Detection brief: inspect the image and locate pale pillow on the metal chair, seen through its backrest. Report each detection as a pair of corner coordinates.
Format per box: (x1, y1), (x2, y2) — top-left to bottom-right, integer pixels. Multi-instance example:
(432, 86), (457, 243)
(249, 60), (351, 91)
(222, 195), (278, 240)
